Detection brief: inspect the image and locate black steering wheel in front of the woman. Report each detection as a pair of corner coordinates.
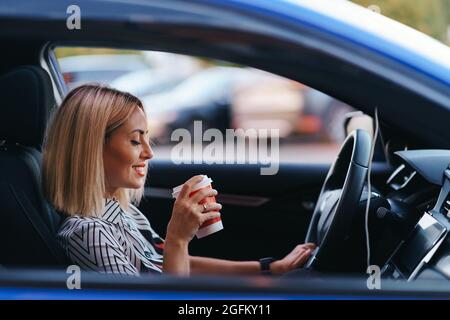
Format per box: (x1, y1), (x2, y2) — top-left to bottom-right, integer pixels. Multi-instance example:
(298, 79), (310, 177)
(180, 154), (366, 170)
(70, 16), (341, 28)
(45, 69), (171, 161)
(305, 129), (372, 271)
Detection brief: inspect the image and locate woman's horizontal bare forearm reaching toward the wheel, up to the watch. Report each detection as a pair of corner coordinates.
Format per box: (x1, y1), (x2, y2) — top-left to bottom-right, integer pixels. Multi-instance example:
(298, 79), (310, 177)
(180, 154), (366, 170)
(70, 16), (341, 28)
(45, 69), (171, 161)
(189, 257), (260, 275)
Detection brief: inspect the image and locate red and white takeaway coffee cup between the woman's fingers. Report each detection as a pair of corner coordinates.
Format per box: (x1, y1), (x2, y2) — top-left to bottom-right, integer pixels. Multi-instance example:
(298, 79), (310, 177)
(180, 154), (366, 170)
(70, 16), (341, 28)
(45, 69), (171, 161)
(172, 175), (223, 239)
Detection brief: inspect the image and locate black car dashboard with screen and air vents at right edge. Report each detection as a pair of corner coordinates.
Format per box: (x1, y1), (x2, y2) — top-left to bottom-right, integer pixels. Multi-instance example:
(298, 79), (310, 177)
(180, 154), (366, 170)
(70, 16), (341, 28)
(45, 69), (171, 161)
(378, 150), (450, 281)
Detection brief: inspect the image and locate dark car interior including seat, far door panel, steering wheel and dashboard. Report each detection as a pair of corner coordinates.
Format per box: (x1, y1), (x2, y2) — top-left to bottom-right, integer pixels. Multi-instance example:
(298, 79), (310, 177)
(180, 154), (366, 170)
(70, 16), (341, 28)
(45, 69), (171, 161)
(0, 4), (450, 298)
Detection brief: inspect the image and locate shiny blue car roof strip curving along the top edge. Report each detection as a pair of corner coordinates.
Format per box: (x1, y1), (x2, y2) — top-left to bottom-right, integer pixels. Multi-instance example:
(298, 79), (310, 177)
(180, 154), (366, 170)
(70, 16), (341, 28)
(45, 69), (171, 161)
(0, 0), (450, 86)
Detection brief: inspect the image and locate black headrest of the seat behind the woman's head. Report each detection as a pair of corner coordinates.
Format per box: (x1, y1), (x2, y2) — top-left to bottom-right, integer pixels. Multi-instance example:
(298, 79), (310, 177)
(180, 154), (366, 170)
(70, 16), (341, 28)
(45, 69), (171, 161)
(0, 66), (55, 148)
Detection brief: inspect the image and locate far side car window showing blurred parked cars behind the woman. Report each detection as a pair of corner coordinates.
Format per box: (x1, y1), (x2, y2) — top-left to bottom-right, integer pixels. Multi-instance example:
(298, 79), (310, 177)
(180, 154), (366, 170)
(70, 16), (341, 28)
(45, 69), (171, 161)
(55, 47), (354, 163)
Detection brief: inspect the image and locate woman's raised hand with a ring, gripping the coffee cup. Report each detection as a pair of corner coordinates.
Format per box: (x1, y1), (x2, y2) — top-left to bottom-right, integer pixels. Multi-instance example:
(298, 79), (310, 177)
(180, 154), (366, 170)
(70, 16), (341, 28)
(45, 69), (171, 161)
(166, 175), (222, 243)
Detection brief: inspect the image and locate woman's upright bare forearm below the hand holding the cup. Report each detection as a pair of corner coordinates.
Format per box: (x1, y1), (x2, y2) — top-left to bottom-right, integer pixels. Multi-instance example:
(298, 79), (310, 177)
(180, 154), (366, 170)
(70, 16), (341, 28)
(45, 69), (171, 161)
(163, 239), (190, 276)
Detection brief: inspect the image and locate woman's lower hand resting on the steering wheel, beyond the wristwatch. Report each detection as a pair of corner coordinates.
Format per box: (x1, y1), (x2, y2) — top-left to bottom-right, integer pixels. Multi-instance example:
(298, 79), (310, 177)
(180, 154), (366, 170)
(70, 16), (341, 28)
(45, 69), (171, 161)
(270, 243), (316, 275)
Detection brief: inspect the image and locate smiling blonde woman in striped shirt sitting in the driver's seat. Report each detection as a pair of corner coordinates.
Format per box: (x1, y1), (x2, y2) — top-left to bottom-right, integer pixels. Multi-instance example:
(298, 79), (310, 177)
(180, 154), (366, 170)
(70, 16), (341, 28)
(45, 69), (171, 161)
(43, 85), (314, 275)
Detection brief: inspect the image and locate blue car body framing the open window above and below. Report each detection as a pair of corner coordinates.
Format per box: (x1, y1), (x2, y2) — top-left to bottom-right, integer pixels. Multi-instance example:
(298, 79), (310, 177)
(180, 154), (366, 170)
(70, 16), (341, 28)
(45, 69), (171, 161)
(0, 0), (450, 299)
